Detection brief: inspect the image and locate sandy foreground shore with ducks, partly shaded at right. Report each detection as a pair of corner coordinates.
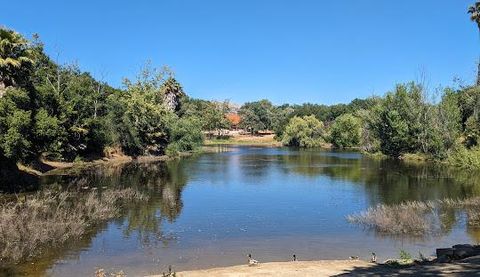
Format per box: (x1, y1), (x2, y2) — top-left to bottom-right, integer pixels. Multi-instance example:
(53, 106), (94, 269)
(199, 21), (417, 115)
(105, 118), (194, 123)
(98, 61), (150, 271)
(151, 256), (480, 277)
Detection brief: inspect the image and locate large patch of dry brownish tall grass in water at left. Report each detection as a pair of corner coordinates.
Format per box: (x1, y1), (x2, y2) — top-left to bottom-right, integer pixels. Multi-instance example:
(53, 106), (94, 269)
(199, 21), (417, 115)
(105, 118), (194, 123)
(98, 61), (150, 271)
(0, 189), (146, 263)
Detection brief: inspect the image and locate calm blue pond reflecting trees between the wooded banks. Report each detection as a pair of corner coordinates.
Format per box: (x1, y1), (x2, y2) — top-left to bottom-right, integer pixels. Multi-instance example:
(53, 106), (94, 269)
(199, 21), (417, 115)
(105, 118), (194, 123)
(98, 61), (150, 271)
(5, 146), (480, 276)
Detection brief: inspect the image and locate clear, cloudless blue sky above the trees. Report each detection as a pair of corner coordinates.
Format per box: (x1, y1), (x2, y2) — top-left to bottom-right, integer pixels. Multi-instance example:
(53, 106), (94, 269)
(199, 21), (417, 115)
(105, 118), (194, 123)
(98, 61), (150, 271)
(0, 0), (480, 104)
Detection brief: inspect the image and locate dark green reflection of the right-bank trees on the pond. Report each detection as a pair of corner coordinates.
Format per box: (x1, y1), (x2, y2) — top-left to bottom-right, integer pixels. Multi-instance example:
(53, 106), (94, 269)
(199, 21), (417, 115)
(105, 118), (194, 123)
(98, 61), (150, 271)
(279, 150), (480, 205)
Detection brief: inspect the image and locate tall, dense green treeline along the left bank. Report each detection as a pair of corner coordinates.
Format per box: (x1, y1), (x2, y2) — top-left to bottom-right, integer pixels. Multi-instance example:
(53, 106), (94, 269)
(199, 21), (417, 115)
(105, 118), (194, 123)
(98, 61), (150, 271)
(0, 28), (210, 171)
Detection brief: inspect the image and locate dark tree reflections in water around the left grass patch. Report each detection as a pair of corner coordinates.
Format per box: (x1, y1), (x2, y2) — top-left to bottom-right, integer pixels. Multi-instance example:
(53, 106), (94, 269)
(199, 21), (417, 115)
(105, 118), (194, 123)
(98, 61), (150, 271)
(4, 160), (187, 276)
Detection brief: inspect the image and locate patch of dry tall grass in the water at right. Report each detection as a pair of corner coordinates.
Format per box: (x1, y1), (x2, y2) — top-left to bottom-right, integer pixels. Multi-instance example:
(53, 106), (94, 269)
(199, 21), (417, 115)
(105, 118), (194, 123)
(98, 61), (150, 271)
(347, 197), (480, 236)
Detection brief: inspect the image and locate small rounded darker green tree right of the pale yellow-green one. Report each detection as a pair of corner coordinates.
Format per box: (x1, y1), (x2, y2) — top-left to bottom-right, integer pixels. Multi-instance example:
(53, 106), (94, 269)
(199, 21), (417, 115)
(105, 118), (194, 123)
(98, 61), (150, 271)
(330, 114), (361, 148)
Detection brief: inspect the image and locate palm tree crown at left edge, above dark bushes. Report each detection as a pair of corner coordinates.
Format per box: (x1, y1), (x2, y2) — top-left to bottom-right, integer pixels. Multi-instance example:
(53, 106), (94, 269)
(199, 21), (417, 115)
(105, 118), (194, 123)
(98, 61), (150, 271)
(0, 27), (33, 94)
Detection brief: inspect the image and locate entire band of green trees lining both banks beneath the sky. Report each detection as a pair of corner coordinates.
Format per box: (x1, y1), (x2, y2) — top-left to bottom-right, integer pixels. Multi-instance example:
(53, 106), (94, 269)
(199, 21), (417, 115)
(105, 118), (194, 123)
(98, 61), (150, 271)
(0, 25), (480, 175)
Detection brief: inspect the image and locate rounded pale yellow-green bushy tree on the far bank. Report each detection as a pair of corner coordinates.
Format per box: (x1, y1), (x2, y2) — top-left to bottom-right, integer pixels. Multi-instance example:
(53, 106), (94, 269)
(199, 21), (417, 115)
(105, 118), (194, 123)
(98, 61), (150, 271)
(282, 115), (325, 148)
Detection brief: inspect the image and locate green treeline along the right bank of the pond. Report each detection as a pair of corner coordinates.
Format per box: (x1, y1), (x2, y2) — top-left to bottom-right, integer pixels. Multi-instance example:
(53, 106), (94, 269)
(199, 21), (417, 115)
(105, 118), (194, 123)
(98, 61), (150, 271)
(236, 82), (480, 165)
